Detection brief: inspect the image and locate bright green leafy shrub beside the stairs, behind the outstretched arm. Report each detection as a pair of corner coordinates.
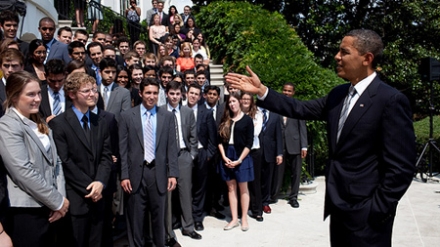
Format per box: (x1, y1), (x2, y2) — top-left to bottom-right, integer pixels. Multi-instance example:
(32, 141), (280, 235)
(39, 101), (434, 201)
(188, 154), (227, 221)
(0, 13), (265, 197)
(196, 1), (343, 172)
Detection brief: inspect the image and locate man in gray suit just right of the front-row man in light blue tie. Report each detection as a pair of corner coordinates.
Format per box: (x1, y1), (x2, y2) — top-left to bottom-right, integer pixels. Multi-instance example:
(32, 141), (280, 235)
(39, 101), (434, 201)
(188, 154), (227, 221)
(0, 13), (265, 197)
(164, 81), (202, 239)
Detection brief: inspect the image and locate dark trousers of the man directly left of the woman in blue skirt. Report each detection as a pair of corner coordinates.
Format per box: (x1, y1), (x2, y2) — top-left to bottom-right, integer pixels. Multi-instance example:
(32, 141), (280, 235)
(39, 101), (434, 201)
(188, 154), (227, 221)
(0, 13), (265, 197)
(192, 148), (210, 222)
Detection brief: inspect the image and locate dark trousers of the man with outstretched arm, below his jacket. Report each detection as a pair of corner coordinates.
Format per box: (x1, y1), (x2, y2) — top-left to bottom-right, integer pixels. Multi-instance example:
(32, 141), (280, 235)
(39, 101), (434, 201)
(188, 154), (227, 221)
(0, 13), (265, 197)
(330, 214), (394, 247)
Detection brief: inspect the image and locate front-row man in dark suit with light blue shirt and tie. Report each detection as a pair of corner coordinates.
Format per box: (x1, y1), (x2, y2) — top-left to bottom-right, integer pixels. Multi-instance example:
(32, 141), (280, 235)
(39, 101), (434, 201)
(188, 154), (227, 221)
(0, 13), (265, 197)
(119, 78), (179, 246)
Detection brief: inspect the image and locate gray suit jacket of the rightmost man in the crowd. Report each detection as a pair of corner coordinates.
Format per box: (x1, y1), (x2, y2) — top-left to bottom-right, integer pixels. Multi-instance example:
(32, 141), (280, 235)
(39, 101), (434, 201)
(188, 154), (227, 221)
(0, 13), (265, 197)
(280, 116), (307, 154)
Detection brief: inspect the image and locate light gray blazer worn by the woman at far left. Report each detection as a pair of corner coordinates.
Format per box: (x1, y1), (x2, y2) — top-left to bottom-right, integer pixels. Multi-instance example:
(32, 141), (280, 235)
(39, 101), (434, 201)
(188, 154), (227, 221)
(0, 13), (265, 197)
(0, 110), (64, 210)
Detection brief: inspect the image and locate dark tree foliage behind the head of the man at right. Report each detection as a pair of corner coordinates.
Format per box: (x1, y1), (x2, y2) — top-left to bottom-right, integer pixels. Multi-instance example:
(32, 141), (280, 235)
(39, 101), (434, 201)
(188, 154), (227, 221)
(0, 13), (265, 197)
(193, 0), (440, 118)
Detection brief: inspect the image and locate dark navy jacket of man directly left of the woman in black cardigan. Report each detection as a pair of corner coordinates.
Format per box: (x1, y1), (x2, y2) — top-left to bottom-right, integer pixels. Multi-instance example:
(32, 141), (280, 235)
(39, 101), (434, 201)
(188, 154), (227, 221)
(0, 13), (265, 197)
(197, 105), (217, 158)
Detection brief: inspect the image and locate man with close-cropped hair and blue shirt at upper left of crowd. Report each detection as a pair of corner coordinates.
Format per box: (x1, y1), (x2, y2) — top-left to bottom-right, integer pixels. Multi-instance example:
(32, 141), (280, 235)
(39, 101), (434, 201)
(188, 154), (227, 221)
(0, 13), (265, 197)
(38, 17), (71, 64)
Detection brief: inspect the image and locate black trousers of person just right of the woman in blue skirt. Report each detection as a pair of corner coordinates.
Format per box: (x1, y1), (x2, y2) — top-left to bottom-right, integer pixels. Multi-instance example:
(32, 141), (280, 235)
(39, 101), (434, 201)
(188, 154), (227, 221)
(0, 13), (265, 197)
(248, 149), (263, 216)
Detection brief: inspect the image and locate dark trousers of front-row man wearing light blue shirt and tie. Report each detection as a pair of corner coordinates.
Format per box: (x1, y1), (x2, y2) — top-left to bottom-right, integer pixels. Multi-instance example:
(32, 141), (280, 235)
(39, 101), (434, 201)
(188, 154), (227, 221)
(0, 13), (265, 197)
(125, 166), (167, 247)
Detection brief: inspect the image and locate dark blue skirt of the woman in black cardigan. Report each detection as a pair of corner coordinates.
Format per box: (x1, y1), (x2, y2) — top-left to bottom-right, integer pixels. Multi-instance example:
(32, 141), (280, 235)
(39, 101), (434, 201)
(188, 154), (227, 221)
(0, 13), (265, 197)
(218, 145), (254, 183)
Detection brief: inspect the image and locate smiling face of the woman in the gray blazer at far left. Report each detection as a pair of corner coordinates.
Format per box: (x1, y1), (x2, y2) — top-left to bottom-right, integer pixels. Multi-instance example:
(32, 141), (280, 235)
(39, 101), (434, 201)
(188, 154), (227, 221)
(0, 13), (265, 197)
(12, 81), (41, 118)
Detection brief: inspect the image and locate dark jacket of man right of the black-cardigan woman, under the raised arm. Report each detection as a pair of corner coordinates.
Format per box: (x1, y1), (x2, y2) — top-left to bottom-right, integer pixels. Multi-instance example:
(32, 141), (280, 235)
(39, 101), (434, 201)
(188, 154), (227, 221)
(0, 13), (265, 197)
(258, 112), (283, 163)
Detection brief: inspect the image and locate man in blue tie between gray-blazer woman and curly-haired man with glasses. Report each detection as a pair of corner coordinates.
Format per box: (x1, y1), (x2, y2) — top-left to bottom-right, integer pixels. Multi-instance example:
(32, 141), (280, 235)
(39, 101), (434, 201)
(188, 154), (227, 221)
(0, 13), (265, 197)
(40, 59), (72, 123)
